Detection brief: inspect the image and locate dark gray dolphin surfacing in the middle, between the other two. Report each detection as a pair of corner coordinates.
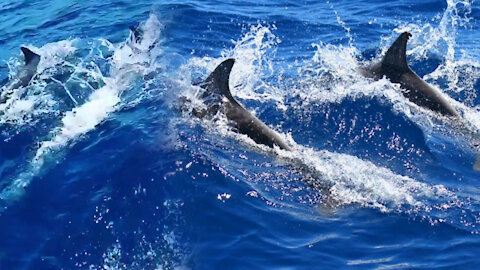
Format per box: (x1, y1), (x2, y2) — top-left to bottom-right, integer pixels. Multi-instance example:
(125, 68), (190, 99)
(194, 59), (290, 150)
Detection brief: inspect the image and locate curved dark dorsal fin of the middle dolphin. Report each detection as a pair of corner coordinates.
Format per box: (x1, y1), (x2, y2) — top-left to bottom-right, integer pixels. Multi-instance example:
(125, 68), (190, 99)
(201, 58), (238, 103)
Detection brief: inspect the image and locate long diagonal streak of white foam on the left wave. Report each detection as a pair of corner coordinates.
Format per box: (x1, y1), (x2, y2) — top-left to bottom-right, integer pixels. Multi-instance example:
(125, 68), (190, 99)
(0, 15), (161, 205)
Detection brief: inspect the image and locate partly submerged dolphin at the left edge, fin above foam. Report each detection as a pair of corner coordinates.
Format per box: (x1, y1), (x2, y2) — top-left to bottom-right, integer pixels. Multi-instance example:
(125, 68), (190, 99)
(0, 47), (40, 103)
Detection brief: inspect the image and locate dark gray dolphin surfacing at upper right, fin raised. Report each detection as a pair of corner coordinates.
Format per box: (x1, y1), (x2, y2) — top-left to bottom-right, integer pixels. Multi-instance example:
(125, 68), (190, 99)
(359, 32), (459, 117)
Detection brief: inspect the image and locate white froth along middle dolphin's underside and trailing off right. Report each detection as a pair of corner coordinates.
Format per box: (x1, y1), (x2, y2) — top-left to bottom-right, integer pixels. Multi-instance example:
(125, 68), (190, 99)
(208, 116), (456, 212)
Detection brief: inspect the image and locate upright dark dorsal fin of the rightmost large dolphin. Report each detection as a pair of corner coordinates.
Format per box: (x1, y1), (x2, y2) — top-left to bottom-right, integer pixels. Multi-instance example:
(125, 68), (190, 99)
(382, 32), (412, 71)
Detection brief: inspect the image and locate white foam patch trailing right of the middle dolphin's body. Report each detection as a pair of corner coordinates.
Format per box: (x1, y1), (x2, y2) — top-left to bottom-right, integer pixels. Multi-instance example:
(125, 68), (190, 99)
(284, 145), (453, 212)
